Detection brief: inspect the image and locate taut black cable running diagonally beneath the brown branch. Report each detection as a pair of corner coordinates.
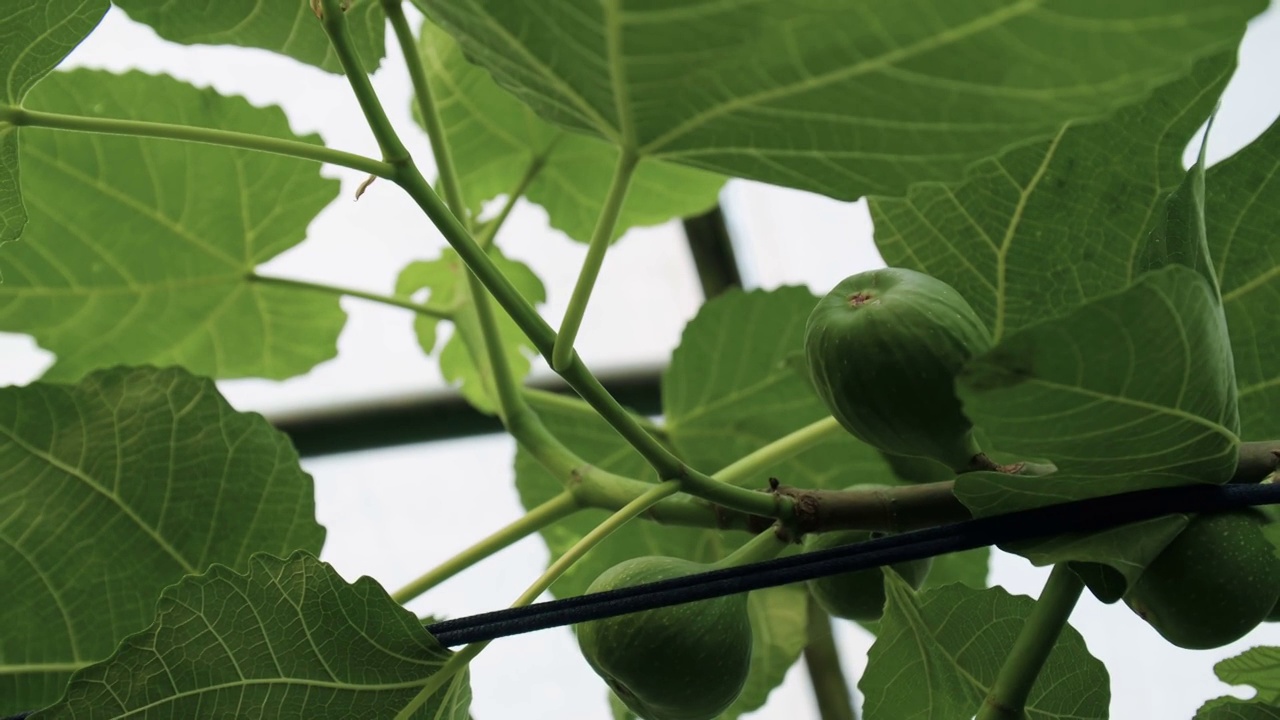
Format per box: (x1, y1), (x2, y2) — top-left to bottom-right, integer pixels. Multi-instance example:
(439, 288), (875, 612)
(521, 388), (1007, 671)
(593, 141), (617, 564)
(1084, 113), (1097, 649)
(426, 484), (1280, 647)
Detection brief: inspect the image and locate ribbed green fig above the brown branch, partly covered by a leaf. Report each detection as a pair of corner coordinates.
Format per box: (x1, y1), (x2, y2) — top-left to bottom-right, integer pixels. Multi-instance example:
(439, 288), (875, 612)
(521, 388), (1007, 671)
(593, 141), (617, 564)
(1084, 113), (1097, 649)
(805, 268), (991, 471)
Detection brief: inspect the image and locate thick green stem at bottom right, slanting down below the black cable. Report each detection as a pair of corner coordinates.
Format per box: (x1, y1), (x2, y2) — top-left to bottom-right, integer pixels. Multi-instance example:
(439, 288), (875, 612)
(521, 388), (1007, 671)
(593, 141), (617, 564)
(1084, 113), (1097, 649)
(977, 562), (1084, 720)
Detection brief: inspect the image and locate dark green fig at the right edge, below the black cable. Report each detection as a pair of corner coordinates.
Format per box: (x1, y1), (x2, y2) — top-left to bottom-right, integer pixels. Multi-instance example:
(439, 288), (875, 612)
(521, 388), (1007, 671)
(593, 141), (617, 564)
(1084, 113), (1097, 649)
(1124, 510), (1280, 650)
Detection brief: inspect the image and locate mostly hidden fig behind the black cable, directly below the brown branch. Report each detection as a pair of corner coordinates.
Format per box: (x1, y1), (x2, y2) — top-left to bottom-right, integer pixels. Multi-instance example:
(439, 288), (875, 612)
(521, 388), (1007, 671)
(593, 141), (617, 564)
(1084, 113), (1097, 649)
(804, 530), (933, 623)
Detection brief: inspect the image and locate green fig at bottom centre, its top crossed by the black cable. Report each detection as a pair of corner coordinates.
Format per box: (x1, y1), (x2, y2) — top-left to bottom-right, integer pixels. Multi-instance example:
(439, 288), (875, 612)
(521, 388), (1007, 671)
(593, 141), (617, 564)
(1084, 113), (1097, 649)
(577, 556), (751, 720)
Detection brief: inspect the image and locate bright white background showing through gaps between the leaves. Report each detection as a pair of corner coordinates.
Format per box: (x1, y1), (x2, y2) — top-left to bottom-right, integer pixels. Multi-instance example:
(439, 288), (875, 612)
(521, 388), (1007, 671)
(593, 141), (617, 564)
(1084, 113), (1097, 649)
(0, 9), (1280, 720)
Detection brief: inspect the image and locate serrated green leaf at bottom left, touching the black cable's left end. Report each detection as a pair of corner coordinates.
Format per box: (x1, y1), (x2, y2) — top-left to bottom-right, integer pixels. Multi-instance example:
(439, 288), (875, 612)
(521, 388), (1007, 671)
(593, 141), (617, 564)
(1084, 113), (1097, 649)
(38, 552), (471, 720)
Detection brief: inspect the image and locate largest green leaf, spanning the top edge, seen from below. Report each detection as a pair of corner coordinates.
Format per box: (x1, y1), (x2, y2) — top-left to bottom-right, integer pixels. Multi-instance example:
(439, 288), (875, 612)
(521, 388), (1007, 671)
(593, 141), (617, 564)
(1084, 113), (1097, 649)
(415, 0), (1266, 199)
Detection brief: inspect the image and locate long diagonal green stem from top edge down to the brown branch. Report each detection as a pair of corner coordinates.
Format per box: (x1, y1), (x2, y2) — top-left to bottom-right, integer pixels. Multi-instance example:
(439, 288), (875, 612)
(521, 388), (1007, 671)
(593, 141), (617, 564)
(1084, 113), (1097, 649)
(323, 0), (792, 520)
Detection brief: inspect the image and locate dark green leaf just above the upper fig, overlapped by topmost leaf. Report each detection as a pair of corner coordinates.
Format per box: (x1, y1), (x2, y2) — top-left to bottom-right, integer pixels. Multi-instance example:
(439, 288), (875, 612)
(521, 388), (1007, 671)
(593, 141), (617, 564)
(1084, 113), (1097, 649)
(870, 53), (1235, 341)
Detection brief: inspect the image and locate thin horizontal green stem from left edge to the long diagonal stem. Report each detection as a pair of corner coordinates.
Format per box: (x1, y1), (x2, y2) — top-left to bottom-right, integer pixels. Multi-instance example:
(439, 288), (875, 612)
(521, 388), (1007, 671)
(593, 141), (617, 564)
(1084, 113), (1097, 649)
(0, 105), (396, 178)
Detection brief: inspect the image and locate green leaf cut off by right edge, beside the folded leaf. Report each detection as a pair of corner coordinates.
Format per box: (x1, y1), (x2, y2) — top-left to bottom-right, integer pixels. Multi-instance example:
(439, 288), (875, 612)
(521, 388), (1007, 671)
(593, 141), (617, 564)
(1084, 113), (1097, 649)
(1206, 112), (1280, 439)
